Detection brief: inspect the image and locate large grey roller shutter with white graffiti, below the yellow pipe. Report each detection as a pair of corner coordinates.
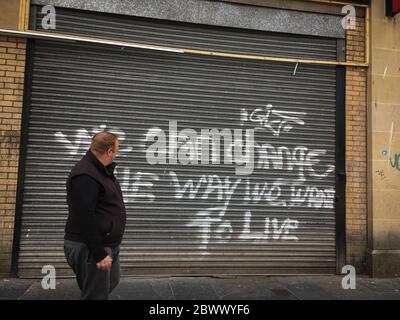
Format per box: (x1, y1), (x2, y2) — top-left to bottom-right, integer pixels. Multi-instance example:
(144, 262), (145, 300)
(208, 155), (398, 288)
(18, 8), (336, 277)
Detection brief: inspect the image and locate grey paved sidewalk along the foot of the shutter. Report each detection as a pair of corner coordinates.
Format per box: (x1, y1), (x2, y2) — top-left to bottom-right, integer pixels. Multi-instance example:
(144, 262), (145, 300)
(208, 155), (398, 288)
(0, 276), (400, 300)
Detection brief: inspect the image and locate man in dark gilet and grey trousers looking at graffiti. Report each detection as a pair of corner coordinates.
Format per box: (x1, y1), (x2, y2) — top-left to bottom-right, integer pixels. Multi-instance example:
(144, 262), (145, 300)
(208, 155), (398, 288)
(64, 131), (126, 299)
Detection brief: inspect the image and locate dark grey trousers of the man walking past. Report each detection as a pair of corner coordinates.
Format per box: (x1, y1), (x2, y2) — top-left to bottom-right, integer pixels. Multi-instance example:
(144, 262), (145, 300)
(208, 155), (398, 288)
(64, 240), (120, 300)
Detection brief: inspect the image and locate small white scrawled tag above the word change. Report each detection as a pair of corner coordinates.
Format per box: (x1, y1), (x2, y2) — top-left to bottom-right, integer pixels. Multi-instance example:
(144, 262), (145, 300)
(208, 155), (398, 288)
(240, 104), (306, 136)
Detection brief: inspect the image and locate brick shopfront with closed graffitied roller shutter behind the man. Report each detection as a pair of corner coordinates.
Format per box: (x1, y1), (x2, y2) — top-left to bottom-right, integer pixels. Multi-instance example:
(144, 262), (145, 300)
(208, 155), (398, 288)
(0, 0), (400, 277)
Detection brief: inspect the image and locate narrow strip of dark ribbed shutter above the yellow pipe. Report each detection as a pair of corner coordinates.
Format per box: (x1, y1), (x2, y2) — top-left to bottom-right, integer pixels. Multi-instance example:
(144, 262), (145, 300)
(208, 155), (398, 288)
(35, 8), (337, 60)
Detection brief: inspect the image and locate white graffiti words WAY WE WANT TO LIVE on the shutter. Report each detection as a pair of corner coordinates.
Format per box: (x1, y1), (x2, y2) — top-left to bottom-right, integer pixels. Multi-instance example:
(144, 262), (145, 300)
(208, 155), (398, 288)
(169, 171), (324, 254)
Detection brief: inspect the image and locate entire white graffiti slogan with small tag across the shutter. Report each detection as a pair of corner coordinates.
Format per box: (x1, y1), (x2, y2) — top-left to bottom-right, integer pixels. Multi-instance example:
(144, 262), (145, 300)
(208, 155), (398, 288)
(55, 100), (334, 255)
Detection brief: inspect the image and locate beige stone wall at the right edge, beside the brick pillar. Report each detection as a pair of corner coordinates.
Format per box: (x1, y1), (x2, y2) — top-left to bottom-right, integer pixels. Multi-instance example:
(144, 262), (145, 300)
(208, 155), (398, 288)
(368, 1), (400, 276)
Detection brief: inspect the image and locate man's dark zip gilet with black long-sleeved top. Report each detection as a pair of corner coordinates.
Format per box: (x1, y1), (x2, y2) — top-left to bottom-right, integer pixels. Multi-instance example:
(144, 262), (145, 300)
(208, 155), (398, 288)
(65, 150), (126, 262)
